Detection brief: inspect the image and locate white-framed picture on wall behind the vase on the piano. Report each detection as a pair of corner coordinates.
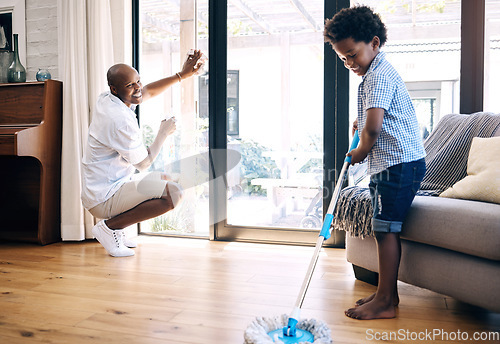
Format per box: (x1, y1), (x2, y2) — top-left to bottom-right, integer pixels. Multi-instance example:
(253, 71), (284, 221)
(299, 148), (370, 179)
(0, 0), (26, 66)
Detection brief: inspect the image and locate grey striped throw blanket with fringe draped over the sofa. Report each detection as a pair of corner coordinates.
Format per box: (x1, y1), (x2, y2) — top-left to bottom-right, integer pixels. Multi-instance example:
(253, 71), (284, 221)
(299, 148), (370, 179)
(332, 112), (500, 238)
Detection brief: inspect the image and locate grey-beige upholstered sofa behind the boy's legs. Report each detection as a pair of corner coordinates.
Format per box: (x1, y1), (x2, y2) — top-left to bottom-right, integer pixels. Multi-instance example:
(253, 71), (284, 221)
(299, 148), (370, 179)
(346, 113), (500, 312)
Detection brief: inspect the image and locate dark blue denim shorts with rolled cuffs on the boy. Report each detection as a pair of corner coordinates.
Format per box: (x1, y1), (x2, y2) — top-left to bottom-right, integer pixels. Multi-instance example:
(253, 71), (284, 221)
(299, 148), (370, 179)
(370, 158), (425, 233)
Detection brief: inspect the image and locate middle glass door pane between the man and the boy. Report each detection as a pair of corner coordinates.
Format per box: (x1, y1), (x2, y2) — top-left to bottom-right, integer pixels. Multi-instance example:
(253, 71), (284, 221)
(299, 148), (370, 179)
(216, 0), (338, 243)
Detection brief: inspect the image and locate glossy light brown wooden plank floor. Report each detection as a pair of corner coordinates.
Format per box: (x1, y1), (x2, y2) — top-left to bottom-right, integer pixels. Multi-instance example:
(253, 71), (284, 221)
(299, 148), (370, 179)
(0, 236), (500, 344)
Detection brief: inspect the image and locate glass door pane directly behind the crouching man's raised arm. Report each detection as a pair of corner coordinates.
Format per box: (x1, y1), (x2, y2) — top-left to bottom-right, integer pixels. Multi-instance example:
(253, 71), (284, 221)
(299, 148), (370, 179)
(137, 0), (210, 237)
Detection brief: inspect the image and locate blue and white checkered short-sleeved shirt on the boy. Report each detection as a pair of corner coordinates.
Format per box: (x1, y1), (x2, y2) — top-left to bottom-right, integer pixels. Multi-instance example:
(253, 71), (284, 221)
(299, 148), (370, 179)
(358, 52), (425, 175)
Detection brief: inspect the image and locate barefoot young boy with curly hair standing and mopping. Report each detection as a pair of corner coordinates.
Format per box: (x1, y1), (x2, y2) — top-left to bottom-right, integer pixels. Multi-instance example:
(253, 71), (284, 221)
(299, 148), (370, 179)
(324, 6), (425, 319)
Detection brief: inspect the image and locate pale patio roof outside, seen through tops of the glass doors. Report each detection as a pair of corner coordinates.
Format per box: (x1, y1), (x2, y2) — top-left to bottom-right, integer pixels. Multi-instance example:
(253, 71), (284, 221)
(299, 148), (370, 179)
(139, 0), (500, 43)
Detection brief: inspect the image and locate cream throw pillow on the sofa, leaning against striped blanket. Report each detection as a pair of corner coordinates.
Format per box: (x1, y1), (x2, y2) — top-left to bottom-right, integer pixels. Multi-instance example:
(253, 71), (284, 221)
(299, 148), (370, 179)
(440, 137), (500, 204)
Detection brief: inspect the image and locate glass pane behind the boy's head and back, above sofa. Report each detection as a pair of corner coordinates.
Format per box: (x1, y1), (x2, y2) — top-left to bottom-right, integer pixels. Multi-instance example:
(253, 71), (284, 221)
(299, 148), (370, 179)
(350, 0), (461, 137)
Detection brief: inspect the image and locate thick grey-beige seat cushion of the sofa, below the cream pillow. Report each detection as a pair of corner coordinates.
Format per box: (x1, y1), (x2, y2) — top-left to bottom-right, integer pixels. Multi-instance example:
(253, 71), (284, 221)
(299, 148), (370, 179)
(401, 196), (500, 260)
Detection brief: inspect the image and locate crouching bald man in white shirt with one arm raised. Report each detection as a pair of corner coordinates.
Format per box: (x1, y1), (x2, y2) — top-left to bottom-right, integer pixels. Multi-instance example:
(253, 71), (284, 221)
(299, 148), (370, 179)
(82, 50), (202, 257)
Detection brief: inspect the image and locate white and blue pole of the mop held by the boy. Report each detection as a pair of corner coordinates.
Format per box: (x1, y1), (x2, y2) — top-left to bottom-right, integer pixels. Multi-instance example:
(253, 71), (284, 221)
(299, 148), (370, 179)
(295, 130), (359, 309)
